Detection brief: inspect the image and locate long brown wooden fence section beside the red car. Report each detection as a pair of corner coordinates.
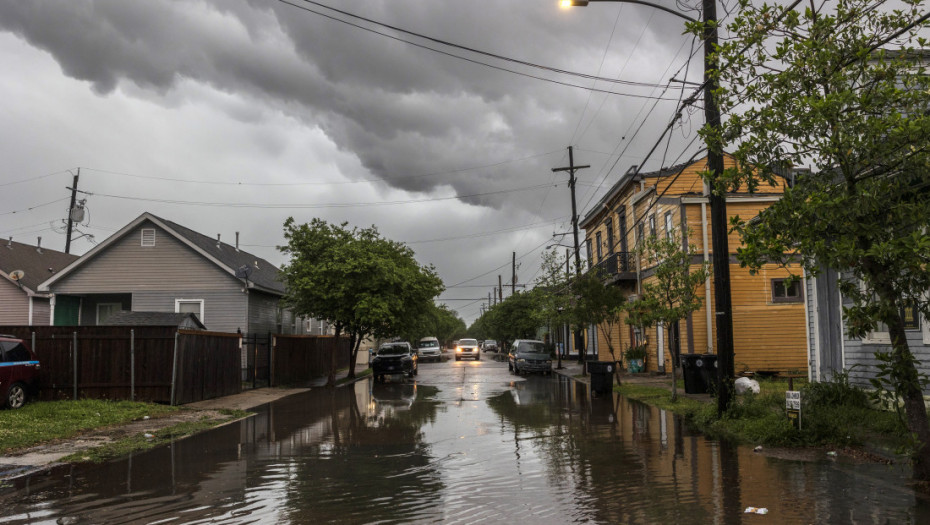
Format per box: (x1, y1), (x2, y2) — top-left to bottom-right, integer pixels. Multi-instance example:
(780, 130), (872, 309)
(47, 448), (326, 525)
(0, 326), (242, 404)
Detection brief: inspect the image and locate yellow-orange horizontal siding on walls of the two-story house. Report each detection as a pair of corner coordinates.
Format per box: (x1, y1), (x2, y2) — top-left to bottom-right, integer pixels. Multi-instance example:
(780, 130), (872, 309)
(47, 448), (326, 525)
(583, 157), (810, 373)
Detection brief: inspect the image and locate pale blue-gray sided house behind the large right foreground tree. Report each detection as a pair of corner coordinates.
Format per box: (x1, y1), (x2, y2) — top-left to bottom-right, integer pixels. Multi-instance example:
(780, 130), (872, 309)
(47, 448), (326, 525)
(805, 269), (930, 395)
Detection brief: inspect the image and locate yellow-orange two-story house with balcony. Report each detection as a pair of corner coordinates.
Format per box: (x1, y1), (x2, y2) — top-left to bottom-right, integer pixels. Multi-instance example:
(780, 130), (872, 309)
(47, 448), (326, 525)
(580, 155), (808, 374)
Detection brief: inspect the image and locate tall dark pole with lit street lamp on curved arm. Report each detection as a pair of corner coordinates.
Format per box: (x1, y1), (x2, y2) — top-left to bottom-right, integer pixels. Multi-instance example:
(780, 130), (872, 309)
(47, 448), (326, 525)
(560, 0), (733, 414)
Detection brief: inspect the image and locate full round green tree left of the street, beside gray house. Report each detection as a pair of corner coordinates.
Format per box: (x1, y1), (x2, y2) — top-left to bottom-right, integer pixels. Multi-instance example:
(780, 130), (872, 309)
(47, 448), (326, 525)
(279, 217), (443, 384)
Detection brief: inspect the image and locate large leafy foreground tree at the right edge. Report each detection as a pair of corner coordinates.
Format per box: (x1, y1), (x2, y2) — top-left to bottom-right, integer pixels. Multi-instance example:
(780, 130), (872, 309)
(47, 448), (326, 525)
(716, 0), (930, 481)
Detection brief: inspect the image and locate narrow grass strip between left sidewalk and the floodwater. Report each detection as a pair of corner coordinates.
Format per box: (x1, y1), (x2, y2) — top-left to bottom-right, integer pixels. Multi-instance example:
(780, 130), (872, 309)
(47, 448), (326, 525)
(62, 409), (249, 463)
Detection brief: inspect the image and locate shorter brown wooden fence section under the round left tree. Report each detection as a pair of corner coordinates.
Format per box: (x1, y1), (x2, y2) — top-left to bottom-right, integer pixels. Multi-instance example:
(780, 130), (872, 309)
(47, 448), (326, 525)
(271, 335), (349, 386)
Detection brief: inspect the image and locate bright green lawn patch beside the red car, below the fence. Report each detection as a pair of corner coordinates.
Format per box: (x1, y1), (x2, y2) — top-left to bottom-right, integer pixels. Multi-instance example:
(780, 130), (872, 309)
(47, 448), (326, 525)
(0, 399), (178, 454)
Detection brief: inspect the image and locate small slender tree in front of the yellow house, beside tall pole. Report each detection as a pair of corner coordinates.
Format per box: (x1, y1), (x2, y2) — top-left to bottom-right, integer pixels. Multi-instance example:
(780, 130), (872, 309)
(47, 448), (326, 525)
(629, 230), (710, 401)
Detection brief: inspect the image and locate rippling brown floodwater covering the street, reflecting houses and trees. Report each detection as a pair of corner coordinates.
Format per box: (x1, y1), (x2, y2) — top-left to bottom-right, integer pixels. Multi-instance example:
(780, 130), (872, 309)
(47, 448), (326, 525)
(0, 360), (930, 525)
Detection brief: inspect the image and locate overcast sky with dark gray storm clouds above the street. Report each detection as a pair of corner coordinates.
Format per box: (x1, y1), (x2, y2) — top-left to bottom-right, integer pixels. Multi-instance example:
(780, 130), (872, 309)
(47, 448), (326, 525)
(0, 0), (712, 323)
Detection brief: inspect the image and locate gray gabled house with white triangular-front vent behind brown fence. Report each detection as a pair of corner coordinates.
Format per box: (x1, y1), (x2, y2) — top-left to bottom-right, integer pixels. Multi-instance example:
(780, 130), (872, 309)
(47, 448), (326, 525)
(39, 213), (304, 334)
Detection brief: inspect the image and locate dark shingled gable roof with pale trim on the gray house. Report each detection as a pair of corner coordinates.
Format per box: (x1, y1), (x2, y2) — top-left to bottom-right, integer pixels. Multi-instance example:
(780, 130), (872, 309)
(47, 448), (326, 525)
(39, 212), (285, 295)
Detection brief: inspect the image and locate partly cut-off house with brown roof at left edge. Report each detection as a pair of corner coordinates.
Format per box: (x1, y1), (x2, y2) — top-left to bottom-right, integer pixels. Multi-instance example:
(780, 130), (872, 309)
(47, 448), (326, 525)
(0, 237), (77, 326)
